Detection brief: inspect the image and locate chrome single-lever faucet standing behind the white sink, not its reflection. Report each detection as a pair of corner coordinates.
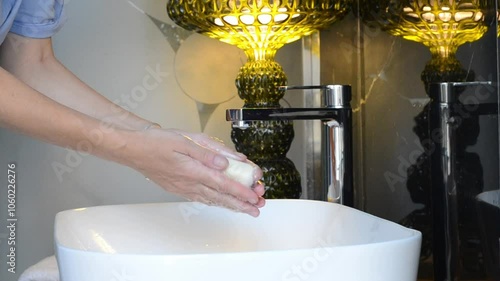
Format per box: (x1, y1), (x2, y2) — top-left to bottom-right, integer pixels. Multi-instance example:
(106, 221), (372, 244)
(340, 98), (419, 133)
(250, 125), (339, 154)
(226, 85), (354, 206)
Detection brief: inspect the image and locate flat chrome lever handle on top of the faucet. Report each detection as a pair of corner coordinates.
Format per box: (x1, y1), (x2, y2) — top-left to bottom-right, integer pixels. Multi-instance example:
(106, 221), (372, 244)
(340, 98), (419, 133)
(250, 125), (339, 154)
(280, 84), (352, 108)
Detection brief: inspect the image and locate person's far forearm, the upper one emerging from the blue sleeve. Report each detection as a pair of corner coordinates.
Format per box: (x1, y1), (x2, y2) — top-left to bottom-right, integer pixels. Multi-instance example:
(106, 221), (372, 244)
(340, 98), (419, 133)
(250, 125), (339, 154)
(1, 34), (151, 129)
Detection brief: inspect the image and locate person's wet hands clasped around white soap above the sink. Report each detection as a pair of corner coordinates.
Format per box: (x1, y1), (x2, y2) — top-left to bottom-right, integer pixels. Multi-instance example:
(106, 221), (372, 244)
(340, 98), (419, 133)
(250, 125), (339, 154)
(127, 128), (265, 217)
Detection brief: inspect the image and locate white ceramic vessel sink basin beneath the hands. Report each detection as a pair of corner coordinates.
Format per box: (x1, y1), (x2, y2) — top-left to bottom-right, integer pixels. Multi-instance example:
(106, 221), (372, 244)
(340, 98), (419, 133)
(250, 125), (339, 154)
(55, 200), (421, 281)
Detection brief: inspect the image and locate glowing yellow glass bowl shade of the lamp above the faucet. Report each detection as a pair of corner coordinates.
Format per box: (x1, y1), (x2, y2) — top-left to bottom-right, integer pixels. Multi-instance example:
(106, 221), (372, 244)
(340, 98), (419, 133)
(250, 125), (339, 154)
(167, 0), (350, 58)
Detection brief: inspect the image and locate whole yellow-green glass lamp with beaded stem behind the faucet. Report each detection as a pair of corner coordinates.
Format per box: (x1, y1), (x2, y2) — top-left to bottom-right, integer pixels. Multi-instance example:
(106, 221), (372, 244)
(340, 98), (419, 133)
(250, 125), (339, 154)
(167, 0), (350, 198)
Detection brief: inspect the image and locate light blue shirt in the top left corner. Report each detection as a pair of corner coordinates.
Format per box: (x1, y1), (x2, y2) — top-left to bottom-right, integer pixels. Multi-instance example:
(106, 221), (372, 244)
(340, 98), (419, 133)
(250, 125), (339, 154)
(0, 0), (66, 44)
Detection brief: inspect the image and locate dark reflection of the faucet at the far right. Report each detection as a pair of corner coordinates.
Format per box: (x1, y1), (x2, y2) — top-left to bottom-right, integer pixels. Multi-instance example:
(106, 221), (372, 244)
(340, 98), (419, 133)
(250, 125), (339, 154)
(426, 81), (498, 280)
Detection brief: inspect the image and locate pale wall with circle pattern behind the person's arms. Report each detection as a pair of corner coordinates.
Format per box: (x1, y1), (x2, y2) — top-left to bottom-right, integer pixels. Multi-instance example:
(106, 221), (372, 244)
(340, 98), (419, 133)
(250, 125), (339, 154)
(0, 0), (301, 281)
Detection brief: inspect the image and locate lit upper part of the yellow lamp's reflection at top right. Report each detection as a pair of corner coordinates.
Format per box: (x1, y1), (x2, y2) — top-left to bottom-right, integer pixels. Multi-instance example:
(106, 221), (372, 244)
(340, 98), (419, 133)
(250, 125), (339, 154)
(360, 0), (491, 87)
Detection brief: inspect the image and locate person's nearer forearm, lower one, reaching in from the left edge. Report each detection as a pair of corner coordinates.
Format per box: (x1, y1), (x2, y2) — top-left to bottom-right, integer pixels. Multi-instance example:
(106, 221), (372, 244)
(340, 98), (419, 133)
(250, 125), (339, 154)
(0, 68), (134, 164)
